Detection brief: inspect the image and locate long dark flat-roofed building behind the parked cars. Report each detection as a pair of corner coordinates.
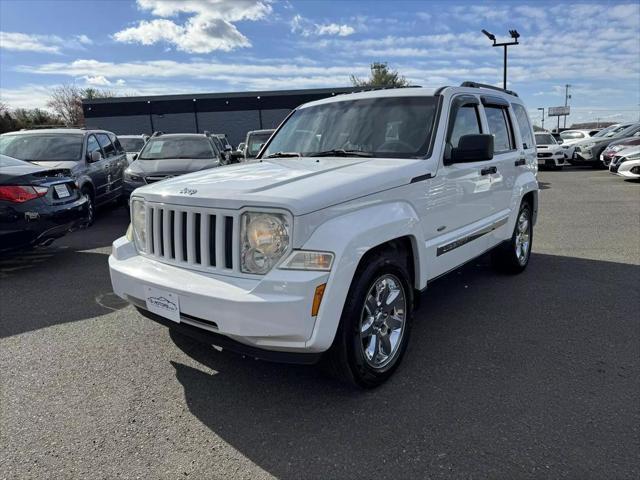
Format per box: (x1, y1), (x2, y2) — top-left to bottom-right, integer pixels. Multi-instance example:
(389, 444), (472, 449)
(82, 87), (358, 146)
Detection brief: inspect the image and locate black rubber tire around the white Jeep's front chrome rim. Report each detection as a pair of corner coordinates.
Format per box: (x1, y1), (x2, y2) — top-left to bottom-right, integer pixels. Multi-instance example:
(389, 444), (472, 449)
(325, 250), (413, 388)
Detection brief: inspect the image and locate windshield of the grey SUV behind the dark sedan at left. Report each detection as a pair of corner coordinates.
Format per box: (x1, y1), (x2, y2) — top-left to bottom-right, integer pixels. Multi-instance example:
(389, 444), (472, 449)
(0, 133), (83, 162)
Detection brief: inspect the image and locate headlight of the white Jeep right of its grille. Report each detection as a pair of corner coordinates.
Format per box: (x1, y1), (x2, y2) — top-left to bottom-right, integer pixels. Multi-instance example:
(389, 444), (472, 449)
(241, 212), (290, 274)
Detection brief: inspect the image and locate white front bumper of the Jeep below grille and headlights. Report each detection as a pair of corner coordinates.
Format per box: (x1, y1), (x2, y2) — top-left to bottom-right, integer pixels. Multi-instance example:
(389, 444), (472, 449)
(109, 237), (329, 356)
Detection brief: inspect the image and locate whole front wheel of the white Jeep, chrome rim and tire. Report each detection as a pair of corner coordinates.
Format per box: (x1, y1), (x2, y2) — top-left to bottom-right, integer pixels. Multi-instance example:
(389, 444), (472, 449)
(328, 249), (413, 388)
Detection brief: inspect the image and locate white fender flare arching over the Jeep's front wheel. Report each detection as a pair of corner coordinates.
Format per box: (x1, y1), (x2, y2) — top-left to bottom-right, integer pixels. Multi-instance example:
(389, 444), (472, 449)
(303, 201), (426, 351)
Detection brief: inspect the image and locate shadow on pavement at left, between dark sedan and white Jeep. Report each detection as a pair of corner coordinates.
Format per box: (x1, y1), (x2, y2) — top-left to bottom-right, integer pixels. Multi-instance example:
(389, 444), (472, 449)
(0, 204), (128, 338)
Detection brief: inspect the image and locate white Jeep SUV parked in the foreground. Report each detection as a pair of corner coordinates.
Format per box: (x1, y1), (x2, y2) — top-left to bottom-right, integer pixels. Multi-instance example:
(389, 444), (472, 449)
(109, 82), (538, 387)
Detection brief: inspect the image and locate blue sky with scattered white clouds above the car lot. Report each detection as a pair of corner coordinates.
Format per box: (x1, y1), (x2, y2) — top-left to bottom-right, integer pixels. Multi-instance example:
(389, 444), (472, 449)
(0, 0), (640, 125)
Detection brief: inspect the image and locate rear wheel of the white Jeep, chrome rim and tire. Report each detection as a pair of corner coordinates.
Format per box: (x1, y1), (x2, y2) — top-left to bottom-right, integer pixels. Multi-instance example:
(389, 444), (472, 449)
(491, 201), (533, 273)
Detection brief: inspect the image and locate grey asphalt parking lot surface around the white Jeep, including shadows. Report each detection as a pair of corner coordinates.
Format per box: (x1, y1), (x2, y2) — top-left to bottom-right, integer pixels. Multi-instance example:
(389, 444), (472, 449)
(0, 169), (640, 479)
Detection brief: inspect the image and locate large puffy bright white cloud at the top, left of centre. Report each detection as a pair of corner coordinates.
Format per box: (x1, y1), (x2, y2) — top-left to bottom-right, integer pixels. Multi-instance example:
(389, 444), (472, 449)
(113, 0), (272, 53)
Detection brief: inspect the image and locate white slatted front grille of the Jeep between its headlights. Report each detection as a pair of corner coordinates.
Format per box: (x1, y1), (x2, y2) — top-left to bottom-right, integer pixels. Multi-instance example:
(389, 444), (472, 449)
(146, 203), (238, 271)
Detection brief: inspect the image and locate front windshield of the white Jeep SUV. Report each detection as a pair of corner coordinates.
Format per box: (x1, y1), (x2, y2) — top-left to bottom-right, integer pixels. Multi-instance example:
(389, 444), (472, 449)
(263, 96), (436, 158)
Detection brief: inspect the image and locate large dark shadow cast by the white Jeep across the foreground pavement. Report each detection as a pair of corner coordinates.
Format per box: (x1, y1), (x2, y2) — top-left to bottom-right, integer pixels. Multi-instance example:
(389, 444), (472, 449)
(172, 254), (640, 479)
